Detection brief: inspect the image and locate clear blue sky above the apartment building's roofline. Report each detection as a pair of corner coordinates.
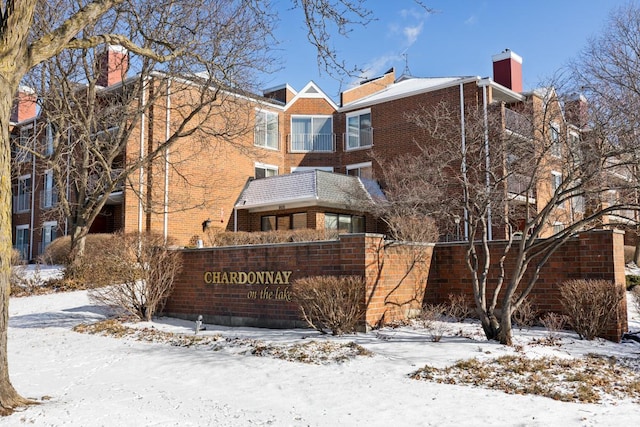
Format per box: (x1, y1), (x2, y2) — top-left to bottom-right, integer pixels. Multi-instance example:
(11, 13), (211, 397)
(264, 0), (627, 100)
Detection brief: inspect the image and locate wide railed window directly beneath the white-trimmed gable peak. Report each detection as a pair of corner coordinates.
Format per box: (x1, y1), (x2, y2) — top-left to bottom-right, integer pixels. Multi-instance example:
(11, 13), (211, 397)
(289, 116), (334, 152)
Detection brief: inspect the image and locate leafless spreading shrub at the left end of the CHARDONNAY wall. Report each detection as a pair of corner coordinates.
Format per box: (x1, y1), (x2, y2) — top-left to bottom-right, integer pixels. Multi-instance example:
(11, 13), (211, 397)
(88, 234), (182, 321)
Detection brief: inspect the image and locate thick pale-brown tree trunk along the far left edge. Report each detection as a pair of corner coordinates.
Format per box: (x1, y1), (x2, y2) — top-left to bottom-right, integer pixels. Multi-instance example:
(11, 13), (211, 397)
(0, 84), (30, 414)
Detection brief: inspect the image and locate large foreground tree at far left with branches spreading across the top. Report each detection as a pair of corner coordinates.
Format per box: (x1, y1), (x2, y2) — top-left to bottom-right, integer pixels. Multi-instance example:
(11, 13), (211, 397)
(0, 0), (432, 413)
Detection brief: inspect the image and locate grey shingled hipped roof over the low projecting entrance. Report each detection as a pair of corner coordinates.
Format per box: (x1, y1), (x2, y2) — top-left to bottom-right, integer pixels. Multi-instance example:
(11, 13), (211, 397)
(235, 170), (384, 211)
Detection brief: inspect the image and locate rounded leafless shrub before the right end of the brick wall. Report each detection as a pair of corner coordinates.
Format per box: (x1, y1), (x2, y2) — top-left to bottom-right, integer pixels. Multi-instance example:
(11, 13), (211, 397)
(560, 279), (624, 340)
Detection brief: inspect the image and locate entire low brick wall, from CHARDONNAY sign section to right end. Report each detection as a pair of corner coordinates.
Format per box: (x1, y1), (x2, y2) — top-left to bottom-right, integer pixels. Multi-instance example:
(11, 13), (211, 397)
(164, 230), (627, 341)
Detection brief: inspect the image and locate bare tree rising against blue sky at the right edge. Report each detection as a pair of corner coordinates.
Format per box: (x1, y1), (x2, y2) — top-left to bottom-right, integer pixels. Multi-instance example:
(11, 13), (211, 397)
(569, 3), (640, 265)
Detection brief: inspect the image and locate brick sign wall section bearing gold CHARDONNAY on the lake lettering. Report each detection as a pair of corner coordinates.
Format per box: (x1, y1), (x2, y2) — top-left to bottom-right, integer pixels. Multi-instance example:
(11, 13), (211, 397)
(164, 234), (433, 327)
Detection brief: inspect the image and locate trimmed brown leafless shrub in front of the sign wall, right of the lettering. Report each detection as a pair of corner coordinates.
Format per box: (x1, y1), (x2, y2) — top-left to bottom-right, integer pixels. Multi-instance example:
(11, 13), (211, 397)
(293, 276), (365, 335)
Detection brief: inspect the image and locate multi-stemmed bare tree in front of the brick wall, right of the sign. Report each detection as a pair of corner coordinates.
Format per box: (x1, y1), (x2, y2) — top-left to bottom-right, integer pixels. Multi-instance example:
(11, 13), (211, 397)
(396, 88), (637, 344)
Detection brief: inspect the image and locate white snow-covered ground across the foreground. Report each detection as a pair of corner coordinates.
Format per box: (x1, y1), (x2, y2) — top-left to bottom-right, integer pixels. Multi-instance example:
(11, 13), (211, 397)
(0, 268), (640, 426)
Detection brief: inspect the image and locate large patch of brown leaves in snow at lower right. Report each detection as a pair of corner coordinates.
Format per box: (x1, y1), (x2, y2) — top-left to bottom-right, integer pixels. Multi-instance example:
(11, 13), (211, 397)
(410, 355), (640, 403)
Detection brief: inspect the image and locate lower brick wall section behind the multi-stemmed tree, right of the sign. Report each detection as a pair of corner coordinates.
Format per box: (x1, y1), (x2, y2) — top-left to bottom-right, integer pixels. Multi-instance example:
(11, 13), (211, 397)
(425, 230), (627, 341)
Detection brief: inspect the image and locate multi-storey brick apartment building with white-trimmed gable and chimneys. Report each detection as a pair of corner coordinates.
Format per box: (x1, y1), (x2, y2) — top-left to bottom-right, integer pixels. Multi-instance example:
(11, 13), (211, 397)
(12, 49), (608, 260)
